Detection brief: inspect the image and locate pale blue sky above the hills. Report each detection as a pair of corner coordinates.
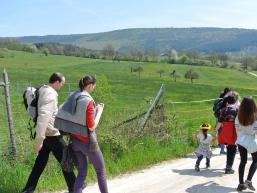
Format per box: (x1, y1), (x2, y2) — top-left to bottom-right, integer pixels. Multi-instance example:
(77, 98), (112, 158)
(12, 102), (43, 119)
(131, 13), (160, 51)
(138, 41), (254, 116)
(0, 0), (257, 37)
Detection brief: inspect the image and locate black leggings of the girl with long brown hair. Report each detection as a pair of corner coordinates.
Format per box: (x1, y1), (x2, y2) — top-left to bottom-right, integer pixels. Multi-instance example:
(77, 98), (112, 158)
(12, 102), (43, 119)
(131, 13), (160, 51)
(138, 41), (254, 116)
(238, 145), (257, 184)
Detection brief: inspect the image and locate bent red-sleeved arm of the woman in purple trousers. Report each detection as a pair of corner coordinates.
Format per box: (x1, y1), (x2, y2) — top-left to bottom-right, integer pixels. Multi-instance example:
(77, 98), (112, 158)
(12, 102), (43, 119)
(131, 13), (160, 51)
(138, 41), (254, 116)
(86, 100), (103, 131)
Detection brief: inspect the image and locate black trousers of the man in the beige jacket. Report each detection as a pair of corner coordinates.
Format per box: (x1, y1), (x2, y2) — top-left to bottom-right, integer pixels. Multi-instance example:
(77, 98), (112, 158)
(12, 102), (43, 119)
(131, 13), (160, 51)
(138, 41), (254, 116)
(23, 136), (76, 192)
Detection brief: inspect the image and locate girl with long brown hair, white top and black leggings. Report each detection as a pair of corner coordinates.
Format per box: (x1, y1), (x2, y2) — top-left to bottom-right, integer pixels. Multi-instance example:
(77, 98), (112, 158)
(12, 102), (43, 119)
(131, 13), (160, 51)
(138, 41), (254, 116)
(235, 97), (257, 191)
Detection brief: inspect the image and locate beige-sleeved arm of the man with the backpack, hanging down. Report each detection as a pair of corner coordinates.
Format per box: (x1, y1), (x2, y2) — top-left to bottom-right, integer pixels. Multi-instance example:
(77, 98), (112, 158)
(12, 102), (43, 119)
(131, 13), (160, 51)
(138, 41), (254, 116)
(34, 93), (56, 152)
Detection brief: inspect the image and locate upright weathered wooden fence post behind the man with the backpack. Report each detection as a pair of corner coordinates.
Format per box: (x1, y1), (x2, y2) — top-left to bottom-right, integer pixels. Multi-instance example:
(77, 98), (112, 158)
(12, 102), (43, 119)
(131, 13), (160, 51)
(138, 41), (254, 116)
(3, 69), (17, 157)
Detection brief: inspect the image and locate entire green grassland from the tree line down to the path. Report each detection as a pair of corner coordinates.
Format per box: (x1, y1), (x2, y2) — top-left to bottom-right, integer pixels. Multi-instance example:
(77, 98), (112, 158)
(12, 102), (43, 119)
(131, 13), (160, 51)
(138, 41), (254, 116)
(0, 51), (257, 193)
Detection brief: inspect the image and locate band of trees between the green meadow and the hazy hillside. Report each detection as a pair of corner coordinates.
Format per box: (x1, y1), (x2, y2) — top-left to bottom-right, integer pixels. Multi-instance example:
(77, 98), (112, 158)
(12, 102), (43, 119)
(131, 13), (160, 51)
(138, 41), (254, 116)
(0, 38), (257, 70)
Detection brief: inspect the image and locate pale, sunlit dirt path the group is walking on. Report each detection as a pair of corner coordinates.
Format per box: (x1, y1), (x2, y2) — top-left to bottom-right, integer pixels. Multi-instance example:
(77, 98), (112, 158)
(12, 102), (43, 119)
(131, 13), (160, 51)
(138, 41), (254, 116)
(53, 149), (257, 193)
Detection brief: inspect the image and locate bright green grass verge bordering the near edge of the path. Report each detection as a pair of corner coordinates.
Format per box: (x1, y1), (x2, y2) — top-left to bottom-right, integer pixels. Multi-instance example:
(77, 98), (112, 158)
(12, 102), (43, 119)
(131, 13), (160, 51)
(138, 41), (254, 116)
(0, 138), (193, 193)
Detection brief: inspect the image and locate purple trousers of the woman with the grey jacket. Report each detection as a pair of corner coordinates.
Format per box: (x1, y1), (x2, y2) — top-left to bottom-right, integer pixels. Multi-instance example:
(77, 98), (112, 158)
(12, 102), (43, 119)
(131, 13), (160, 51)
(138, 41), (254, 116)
(72, 139), (108, 193)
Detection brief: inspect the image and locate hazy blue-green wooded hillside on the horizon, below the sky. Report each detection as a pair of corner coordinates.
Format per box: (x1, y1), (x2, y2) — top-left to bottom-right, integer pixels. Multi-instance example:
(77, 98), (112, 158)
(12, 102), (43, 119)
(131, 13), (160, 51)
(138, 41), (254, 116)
(18, 28), (257, 53)
